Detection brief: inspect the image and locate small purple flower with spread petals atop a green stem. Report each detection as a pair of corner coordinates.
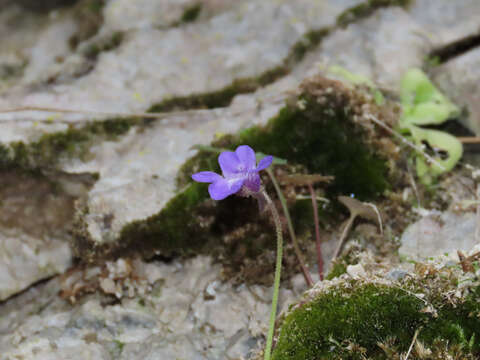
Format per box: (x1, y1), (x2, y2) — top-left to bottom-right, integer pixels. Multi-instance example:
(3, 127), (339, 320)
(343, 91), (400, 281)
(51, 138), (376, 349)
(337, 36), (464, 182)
(192, 145), (273, 200)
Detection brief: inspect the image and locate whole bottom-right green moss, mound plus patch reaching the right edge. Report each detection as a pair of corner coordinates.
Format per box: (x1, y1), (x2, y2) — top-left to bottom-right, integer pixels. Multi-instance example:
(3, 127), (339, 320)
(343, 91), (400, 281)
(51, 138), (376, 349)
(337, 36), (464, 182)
(273, 282), (480, 360)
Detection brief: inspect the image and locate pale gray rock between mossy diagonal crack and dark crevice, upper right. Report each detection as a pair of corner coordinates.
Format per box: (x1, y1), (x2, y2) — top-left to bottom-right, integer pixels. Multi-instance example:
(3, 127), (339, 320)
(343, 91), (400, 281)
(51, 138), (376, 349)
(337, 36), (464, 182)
(294, 0), (480, 89)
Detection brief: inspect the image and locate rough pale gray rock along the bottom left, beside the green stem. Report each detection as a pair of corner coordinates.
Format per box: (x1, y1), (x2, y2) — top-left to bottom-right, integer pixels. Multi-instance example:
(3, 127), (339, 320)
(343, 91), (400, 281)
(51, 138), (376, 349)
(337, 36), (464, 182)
(0, 257), (303, 360)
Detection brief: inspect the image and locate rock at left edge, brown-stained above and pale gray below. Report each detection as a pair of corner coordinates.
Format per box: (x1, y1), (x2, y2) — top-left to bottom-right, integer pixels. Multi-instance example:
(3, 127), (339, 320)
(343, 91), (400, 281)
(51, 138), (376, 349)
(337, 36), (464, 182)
(0, 171), (91, 301)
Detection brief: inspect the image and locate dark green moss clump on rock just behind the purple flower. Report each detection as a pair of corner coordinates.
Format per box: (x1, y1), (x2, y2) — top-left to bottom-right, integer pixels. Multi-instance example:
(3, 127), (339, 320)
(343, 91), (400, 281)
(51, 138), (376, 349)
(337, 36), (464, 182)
(235, 99), (387, 199)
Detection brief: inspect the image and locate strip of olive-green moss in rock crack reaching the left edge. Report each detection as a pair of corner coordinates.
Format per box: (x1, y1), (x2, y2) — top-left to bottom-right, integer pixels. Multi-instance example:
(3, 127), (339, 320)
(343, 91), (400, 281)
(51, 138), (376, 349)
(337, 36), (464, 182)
(0, 118), (139, 170)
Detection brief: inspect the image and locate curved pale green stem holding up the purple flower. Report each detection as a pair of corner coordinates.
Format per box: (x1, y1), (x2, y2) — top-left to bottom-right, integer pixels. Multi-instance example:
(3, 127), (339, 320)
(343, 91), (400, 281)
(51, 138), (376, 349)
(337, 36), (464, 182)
(262, 190), (283, 360)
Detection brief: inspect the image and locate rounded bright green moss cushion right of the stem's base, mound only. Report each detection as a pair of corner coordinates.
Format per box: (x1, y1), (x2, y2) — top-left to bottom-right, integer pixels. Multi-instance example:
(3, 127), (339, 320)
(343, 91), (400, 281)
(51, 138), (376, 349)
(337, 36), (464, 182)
(273, 285), (428, 360)
